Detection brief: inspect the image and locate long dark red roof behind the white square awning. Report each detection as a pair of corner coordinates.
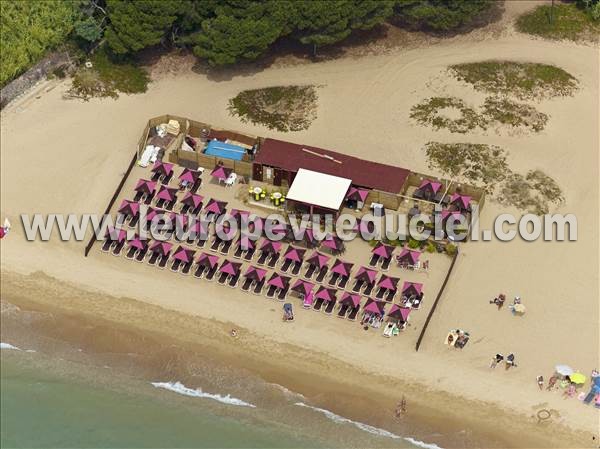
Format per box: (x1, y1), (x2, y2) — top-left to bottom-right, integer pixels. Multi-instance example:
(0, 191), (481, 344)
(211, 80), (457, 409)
(254, 139), (410, 193)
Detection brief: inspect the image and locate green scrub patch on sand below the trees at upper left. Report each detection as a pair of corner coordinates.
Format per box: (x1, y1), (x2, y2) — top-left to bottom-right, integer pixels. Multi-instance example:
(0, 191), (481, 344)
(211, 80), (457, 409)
(69, 51), (150, 101)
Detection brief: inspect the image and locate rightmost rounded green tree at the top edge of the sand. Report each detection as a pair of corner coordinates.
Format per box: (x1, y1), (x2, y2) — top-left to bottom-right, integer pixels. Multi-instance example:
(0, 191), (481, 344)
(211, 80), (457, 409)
(394, 0), (493, 31)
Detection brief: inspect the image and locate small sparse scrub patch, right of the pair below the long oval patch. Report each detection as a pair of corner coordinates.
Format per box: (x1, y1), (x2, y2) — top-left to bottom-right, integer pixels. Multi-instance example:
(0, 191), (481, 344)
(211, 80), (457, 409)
(483, 97), (548, 132)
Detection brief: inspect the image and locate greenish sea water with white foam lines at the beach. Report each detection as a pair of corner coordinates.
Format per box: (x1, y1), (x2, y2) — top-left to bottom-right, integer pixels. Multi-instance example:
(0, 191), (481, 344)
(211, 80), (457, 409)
(0, 343), (437, 448)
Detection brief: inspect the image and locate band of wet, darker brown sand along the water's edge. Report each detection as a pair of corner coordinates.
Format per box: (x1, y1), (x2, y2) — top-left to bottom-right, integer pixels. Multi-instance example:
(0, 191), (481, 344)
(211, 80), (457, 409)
(2, 272), (591, 448)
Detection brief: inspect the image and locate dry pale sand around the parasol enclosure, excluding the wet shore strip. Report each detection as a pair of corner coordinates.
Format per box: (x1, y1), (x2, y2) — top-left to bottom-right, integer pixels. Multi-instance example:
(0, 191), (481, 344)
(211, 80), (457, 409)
(0, 2), (600, 444)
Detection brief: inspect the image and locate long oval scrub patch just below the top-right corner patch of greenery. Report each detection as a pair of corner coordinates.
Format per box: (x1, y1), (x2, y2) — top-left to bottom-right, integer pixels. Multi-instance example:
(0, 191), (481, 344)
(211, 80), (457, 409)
(449, 61), (577, 100)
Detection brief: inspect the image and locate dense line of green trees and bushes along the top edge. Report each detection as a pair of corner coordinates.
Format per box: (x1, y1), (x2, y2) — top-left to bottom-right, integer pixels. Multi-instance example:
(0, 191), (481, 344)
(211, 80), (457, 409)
(0, 0), (492, 83)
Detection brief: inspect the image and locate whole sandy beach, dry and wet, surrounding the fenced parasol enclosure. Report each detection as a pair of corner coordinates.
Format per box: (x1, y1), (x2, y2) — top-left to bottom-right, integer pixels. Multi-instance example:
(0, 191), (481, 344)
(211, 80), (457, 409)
(0, 2), (600, 447)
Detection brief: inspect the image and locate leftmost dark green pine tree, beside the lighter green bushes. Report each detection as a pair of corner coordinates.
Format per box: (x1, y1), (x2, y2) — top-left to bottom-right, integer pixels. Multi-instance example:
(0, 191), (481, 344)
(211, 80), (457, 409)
(105, 0), (184, 54)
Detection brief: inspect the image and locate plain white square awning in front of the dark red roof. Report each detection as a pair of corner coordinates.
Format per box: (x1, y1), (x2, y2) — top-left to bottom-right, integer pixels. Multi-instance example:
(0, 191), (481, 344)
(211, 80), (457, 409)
(287, 168), (352, 210)
